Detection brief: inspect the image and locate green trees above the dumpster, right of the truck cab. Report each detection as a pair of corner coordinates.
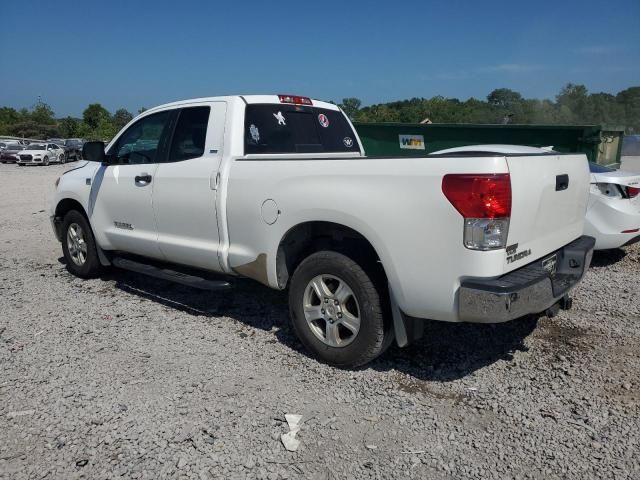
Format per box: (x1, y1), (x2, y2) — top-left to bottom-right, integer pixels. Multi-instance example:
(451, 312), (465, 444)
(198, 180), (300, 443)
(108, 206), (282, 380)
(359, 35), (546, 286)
(340, 83), (640, 133)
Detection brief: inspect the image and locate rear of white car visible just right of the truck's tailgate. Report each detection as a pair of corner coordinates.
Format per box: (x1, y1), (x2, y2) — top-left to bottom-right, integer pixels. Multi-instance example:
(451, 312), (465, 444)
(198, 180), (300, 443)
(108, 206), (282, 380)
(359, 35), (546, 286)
(584, 163), (640, 250)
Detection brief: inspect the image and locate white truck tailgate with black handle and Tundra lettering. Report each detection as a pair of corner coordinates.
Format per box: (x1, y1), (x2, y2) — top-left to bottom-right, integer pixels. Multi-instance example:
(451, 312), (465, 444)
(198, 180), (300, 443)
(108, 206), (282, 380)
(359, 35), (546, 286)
(505, 154), (590, 272)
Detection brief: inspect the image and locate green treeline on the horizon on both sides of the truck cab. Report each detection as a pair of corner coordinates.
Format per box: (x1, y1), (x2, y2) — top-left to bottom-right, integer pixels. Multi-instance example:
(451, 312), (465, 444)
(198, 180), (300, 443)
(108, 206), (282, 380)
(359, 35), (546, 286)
(0, 83), (640, 140)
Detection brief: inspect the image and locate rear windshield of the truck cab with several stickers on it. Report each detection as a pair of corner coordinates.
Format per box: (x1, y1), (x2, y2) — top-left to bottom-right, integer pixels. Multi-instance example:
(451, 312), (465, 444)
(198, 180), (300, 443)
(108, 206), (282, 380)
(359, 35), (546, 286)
(244, 104), (360, 154)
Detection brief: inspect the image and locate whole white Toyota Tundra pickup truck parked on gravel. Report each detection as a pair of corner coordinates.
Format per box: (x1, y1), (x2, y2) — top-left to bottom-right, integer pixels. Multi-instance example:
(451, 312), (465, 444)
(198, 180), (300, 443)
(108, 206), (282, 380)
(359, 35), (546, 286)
(50, 95), (594, 368)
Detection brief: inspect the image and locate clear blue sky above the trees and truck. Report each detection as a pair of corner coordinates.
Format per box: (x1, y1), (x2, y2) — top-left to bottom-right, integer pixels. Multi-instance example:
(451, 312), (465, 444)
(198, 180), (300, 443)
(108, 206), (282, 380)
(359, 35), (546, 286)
(0, 0), (640, 117)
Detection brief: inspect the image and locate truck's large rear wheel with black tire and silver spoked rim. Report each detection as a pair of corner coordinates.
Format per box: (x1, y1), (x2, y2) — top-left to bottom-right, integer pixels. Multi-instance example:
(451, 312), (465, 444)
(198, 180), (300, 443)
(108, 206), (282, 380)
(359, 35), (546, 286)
(289, 251), (392, 368)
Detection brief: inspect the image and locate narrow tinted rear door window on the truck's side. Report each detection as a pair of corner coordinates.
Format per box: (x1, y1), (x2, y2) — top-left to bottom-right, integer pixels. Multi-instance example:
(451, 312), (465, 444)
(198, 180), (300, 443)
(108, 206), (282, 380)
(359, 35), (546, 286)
(169, 107), (211, 162)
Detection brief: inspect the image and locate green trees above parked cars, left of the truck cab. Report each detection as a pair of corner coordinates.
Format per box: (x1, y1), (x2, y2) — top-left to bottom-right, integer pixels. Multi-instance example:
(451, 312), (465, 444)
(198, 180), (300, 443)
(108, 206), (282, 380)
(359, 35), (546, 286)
(0, 102), (145, 140)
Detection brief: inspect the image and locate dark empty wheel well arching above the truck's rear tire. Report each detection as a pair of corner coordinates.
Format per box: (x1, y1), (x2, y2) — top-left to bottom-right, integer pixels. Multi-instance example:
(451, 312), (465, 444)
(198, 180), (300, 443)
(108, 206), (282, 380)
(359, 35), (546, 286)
(276, 222), (387, 288)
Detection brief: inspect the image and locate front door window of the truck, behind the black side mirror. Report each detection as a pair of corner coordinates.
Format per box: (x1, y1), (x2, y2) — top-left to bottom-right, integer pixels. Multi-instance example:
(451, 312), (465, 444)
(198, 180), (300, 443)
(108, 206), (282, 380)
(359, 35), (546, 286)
(109, 111), (170, 164)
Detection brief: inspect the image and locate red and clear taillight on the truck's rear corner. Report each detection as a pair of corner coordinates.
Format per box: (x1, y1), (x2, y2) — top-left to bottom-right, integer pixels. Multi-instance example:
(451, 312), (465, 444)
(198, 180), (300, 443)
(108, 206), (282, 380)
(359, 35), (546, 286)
(442, 173), (511, 250)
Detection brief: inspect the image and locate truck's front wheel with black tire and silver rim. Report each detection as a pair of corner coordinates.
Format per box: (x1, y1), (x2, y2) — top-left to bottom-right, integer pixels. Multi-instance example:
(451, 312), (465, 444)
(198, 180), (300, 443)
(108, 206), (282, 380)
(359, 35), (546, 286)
(62, 210), (103, 278)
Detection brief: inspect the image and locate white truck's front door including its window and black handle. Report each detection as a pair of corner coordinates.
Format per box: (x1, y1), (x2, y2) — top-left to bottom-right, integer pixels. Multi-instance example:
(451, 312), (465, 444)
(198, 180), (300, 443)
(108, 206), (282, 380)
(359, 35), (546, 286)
(89, 111), (172, 259)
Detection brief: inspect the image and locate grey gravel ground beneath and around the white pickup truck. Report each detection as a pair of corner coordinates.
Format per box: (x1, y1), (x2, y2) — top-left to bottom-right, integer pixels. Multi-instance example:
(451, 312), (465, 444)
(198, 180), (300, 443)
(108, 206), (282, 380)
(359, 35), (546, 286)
(0, 164), (640, 479)
